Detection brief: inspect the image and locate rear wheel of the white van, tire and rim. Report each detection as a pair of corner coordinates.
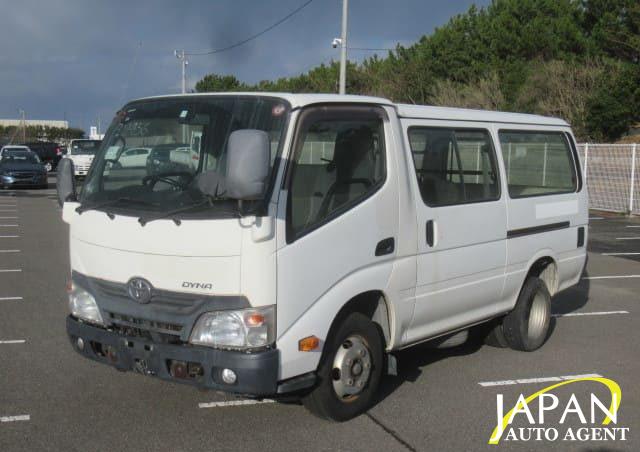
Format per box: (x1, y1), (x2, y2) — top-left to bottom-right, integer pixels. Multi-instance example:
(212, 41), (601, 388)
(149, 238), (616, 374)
(502, 277), (551, 352)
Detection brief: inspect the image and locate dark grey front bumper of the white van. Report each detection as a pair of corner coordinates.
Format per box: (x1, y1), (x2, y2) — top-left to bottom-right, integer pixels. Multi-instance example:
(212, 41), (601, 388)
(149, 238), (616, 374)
(67, 316), (279, 396)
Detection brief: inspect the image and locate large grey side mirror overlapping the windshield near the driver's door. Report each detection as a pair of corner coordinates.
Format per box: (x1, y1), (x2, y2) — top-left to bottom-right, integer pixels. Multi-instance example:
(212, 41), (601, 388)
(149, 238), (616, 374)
(226, 129), (271, 201)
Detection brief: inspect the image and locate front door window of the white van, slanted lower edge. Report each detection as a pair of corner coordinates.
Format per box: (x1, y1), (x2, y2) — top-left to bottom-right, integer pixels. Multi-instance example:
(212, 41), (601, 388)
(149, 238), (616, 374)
(288, 109), (386, 240)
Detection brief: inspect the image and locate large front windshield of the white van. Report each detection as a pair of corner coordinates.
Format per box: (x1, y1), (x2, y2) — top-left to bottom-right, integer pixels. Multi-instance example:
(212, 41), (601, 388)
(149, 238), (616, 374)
(81, 96), (289, 215)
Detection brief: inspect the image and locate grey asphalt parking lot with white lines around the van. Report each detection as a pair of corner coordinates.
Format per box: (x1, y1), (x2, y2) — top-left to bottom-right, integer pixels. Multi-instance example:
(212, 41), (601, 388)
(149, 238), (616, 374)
(0, 178), (640, 451)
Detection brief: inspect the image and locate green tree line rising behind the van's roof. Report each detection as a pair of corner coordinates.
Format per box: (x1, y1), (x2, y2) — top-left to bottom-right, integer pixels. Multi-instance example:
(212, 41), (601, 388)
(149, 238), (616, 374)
(196, 0), (640, 141)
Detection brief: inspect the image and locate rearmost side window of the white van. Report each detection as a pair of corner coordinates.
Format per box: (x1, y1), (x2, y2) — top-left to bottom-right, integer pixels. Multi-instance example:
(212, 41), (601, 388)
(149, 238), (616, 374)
(499, 130), (577, 198)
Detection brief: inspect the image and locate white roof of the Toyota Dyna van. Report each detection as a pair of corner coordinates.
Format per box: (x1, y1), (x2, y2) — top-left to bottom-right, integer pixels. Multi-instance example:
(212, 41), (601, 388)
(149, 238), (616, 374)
(132, 92), (569, 127)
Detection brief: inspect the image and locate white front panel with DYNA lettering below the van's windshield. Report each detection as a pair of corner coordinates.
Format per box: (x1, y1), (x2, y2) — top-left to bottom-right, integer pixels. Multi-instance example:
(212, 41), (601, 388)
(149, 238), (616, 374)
(71, 211), (242, 295)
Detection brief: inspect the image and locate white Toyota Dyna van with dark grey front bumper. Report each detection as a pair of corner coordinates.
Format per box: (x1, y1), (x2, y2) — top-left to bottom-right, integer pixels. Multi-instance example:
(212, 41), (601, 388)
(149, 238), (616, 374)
(58, 93), (588, 421)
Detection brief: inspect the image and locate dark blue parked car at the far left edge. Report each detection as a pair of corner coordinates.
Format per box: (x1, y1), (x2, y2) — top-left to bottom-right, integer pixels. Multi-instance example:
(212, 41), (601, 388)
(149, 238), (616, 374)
(0, 146), (48, 188)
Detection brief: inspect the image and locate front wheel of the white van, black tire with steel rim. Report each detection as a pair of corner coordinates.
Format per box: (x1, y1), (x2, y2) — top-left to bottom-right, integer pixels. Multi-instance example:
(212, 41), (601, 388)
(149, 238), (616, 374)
(302, 312), (384, 422)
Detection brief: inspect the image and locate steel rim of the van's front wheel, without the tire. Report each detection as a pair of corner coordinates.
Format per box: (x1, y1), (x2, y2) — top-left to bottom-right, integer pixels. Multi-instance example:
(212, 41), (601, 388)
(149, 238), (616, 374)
(331, 335), (373, 400)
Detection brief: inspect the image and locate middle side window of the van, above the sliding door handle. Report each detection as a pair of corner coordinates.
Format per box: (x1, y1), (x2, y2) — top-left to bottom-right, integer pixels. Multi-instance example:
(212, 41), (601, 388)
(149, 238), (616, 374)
(409, 127), (500, 207)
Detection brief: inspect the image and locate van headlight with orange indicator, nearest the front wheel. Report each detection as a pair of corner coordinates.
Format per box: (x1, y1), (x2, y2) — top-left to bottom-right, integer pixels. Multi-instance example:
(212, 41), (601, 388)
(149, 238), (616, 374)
(189, 306), (276, 349)
